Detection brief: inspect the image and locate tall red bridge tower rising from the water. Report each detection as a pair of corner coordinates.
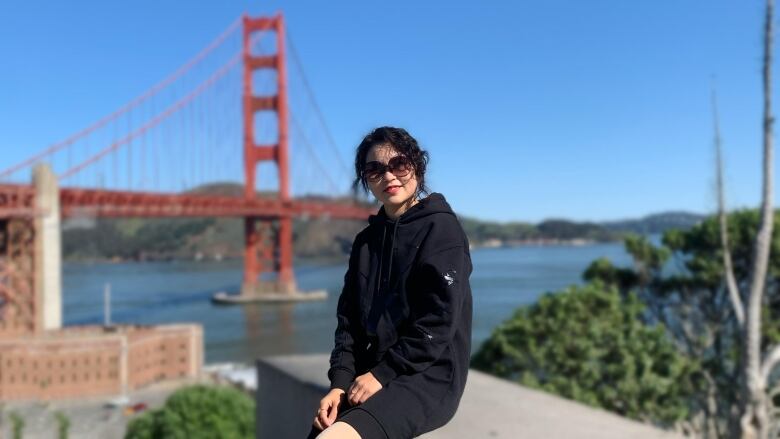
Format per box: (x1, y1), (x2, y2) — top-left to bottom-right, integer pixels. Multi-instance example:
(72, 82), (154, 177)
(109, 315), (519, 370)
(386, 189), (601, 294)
(241, 14), (314, 298)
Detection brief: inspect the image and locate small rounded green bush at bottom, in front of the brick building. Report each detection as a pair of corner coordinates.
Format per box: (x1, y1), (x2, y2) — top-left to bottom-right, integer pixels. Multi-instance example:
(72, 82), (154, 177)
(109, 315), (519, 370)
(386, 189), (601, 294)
(125, 385), (255, 439)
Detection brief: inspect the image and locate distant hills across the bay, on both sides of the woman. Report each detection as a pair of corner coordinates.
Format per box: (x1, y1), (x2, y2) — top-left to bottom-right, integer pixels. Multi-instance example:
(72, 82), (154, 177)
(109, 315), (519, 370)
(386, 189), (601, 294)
(63, 183), (704, 260)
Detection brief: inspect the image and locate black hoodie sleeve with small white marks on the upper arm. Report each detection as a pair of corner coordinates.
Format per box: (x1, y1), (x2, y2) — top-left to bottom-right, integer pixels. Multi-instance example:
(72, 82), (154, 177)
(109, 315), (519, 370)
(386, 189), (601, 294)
(371, 243), (471, 386)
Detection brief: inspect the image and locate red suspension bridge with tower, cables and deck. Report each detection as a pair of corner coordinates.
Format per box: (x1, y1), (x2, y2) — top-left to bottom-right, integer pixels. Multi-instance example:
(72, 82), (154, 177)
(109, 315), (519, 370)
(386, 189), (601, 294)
(0, 14), (371, 326)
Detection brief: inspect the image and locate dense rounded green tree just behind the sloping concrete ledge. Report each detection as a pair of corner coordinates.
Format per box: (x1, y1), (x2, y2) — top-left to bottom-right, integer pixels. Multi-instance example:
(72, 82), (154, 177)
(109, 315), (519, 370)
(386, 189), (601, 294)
(472, 282), (698, 425)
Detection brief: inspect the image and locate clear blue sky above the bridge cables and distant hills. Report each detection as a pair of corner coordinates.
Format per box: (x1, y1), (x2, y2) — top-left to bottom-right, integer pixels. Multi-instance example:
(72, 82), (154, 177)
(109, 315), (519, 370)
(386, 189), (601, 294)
(0, 0), (780, 222)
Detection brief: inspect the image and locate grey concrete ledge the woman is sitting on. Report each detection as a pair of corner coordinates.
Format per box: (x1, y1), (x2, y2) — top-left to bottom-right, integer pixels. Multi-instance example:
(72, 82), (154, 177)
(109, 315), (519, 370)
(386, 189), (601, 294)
(256, 355), (681, 439)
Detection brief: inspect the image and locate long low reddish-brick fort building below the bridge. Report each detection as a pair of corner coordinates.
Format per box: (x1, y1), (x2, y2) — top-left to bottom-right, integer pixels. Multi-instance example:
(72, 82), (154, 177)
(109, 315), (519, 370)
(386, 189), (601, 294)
(0, 325), (203, 401)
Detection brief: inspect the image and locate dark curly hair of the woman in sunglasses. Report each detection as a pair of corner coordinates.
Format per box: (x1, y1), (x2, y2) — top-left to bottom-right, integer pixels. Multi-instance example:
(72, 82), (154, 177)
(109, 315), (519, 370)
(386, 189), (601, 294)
(352, 127), (429, 195)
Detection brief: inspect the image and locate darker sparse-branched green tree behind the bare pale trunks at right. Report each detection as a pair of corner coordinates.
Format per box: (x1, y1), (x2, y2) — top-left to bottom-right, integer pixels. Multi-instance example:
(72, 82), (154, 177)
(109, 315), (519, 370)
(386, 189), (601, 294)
(584, 210), (780, 437)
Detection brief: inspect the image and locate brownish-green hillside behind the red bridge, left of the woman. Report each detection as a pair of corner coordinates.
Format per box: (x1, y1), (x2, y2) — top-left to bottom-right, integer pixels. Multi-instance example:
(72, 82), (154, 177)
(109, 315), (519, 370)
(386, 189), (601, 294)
(63, 183), (369, 260)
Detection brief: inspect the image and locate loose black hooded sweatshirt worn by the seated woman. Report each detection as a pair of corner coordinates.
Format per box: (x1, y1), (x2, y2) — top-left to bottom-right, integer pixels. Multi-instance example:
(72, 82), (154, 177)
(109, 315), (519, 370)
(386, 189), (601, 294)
(328, 192), (472, 434)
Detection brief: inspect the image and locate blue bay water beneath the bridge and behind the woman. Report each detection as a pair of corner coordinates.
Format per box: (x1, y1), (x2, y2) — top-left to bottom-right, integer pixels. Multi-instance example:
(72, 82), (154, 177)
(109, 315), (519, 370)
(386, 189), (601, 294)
(63, 242), (630, 363)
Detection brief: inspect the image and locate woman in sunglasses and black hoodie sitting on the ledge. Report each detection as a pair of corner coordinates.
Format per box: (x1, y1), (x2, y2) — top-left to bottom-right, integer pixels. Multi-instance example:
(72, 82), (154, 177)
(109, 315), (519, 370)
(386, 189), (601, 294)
(309, 127), (472, 439)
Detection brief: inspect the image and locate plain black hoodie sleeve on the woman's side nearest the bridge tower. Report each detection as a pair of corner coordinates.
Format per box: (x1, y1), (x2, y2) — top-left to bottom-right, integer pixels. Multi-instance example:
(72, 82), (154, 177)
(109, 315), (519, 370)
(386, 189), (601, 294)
(328, 237), (366, 392)
